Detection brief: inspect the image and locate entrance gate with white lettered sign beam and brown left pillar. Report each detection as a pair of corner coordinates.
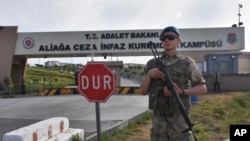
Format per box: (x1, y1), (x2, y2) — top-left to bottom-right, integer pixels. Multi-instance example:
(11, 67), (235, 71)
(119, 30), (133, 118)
(0, 26), (245, 92)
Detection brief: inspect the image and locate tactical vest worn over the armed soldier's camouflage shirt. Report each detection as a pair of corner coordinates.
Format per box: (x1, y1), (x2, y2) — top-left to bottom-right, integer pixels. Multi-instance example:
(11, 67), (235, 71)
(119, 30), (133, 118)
(149, 57), (190, 115)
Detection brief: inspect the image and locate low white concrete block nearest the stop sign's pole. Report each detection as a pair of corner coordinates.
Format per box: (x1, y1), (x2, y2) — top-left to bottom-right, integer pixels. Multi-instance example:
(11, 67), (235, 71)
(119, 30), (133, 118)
(47, 128), (84, 141)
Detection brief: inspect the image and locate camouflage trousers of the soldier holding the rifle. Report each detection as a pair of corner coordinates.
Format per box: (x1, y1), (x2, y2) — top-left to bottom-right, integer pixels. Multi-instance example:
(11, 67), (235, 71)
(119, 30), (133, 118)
(151, 112), (194, 141)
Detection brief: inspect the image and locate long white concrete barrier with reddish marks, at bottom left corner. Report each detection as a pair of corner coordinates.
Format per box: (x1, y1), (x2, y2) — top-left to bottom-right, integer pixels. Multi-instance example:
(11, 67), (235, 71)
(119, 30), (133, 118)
(3, 117), (69, 141)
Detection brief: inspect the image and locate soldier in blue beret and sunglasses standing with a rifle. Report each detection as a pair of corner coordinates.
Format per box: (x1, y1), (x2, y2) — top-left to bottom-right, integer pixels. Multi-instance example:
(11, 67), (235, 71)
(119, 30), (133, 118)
(140, 26), (207, 141)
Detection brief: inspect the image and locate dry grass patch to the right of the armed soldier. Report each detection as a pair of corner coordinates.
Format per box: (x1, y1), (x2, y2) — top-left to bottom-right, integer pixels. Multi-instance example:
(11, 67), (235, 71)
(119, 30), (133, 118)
(190, 92), (250, 141)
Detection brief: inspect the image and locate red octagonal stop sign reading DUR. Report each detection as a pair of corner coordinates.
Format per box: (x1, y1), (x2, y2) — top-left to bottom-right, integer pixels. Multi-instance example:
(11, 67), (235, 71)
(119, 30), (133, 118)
(78, 62), (115, 102)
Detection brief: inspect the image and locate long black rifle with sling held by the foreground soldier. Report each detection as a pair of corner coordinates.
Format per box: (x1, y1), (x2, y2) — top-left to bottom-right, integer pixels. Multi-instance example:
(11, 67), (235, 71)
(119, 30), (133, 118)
(149, 41), (198, 141)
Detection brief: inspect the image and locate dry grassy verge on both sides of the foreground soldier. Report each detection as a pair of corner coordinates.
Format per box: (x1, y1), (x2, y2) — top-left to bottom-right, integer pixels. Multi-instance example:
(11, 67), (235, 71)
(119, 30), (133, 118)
(99, 92), (250, 141)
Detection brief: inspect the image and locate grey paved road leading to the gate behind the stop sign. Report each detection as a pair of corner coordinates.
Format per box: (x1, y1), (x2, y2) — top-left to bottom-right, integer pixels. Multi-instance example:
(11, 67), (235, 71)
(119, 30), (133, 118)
(0, 77), (148, 140)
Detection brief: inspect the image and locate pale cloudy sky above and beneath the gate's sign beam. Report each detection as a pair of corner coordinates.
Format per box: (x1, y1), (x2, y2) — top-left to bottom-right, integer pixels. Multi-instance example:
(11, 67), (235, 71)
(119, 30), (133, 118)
(0, 0), (250, 65)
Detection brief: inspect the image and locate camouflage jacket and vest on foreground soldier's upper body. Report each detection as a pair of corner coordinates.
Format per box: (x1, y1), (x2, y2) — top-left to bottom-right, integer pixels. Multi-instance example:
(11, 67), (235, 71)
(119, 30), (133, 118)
(146, 53), (205, 115)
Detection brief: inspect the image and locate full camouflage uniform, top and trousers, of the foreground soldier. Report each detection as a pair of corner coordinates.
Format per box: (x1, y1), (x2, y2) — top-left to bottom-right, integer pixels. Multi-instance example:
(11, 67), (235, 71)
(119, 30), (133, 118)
(146, 52), (205, 141)
